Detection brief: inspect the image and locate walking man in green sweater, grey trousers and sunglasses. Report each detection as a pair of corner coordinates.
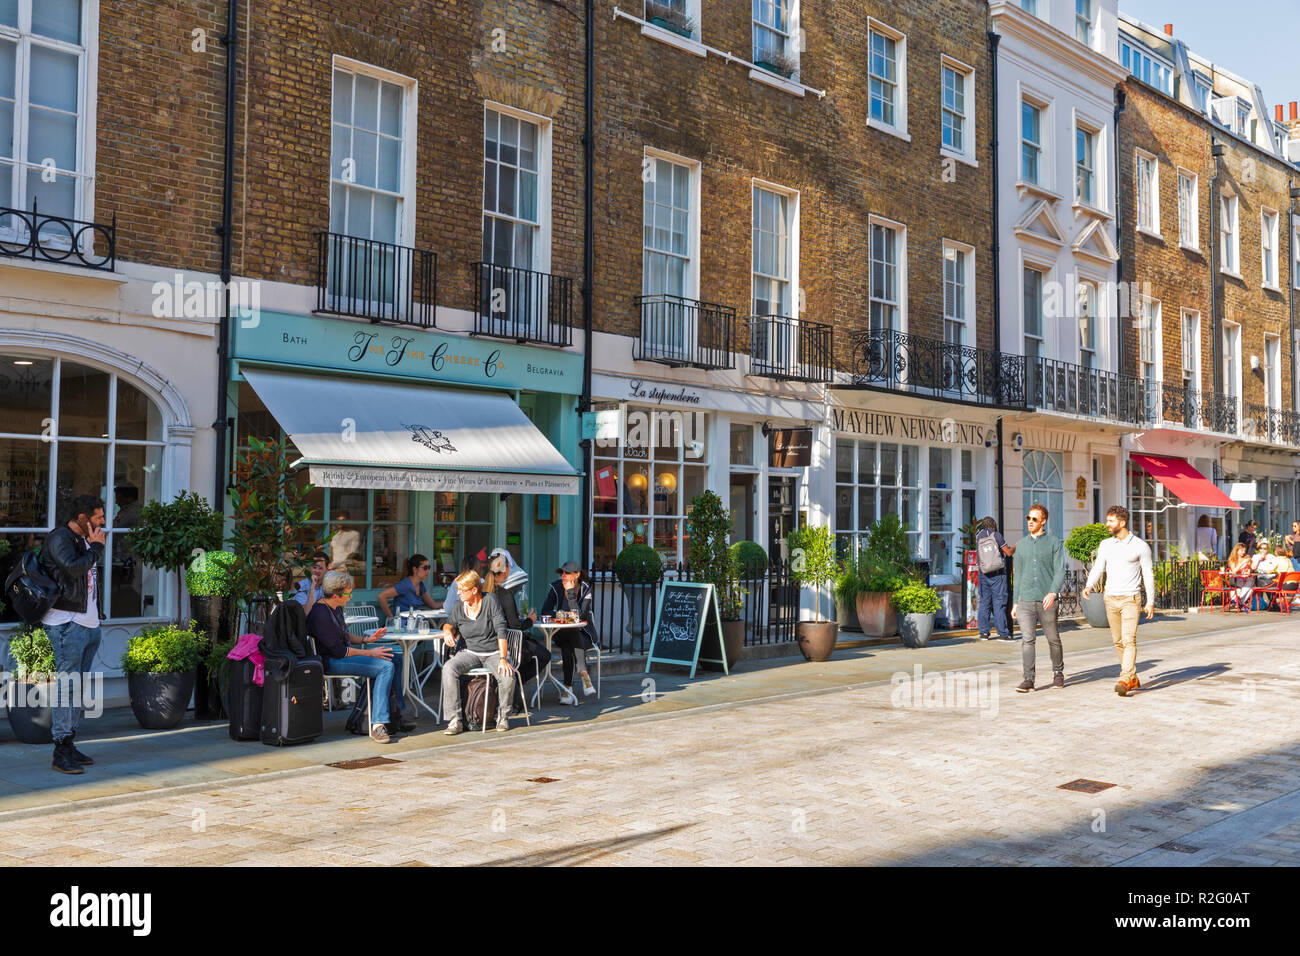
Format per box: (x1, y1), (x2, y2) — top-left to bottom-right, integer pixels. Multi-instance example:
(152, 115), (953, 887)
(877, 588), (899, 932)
(1011, 502), (1065, 693)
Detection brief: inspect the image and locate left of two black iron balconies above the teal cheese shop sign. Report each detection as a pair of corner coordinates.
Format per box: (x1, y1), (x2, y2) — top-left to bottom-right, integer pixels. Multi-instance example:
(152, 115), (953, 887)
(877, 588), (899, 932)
(316, 233), (438, 329)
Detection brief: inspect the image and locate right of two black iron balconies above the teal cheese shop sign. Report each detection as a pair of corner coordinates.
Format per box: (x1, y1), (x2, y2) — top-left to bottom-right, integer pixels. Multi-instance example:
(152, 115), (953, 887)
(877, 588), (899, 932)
(473, 263), (573, 346)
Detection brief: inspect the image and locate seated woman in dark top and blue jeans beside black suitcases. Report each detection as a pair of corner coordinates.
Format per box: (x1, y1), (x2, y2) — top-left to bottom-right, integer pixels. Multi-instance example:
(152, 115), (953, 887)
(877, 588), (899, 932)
(307, 571), (416, 744)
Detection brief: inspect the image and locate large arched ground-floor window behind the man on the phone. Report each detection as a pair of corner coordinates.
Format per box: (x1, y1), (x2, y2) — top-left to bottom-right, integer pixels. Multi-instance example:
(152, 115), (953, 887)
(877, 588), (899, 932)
(0, 354), (165, 623)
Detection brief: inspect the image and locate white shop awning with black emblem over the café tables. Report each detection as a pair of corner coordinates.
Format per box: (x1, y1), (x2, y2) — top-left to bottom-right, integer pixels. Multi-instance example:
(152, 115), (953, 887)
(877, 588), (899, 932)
(242, 368), (580, 494)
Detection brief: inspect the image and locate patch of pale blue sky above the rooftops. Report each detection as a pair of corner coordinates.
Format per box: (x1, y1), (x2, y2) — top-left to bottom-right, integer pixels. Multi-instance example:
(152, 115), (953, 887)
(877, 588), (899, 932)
(1119, 0), (1300, 118)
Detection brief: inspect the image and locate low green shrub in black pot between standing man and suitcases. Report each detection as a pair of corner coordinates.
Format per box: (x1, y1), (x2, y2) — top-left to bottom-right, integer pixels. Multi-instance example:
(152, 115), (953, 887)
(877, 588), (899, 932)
(122, 620), (211, 730)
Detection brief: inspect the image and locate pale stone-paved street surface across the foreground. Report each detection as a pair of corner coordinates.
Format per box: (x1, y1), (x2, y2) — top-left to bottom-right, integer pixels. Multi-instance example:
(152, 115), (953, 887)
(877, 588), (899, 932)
(0, 623), (1300, 865)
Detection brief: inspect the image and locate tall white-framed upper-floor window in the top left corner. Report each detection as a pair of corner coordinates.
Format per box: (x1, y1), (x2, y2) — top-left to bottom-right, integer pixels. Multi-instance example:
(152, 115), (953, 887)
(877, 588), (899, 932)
(0, 0), (98, 234)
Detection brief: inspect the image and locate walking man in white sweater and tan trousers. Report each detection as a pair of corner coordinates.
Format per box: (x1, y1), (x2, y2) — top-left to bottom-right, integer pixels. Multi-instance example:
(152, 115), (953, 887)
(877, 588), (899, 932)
(1082, 505), (1156, 697)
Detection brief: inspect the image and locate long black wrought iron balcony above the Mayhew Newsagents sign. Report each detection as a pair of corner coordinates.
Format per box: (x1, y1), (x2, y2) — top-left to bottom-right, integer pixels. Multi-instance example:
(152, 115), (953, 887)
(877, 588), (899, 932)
(850, 329), (1024, 408)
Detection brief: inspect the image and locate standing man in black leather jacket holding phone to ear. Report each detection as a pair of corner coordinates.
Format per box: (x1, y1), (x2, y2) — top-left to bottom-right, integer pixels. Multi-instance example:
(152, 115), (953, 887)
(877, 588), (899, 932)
(40, 494), (104, 774)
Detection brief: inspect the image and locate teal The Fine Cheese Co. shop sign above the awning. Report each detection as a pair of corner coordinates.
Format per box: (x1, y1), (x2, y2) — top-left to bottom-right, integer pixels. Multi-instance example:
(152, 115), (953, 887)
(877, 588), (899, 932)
(234, 311), (582, 394)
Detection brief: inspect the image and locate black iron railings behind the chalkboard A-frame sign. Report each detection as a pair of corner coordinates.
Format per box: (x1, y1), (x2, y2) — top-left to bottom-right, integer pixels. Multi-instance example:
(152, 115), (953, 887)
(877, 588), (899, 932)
(588, 562), (795, 654)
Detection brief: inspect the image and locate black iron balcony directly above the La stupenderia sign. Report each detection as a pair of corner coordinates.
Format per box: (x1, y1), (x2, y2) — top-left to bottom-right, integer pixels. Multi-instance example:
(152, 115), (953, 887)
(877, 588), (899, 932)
(632, 294), (736, 368)
